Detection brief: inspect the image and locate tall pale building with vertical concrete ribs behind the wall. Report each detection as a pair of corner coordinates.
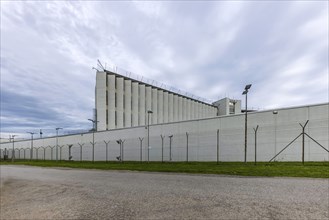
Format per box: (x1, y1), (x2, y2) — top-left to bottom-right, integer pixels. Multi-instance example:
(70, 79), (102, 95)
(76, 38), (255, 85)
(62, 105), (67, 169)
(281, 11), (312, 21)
(95, 70), (218, 131)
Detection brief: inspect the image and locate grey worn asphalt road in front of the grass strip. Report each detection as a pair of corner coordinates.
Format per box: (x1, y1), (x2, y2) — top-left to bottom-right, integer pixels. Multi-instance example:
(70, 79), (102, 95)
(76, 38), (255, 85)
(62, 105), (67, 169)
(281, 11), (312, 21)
(0, 166), (329, 220)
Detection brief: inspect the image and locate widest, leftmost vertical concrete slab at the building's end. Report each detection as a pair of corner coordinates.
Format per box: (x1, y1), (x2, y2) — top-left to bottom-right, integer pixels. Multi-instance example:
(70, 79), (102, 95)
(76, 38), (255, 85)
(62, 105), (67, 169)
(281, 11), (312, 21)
(95, 72), (107, 131)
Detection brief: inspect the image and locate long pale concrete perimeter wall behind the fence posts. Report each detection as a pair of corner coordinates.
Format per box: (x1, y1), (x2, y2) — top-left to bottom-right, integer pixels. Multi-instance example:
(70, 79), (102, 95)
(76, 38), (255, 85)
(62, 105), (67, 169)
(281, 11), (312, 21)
(0, 103), (329, 161)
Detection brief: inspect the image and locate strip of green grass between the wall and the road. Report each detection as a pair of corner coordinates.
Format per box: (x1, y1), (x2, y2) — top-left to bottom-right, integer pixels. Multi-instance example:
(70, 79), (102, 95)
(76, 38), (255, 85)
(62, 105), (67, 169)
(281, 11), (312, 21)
(0, 160), (329, 178)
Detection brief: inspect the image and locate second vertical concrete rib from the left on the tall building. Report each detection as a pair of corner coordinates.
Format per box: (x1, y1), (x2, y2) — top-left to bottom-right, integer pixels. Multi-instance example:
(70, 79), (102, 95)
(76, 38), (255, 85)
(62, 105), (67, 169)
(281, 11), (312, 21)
(107, 75), (115, 129)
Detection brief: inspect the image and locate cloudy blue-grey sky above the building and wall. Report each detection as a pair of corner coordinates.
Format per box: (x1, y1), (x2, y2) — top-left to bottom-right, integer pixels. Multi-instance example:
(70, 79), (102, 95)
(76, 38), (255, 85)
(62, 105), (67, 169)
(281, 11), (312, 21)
(0, 1), (329, 138)
